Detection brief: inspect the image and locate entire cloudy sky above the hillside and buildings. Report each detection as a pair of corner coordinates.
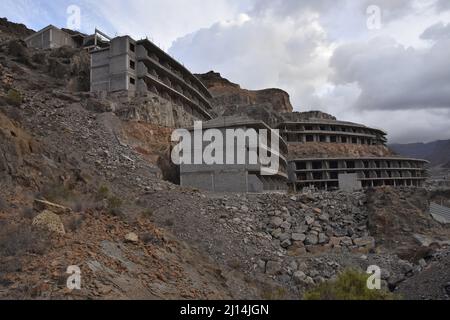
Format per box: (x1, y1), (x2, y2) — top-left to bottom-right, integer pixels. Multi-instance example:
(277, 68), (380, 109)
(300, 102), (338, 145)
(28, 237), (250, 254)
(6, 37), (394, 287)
(0, 0), (450, 143)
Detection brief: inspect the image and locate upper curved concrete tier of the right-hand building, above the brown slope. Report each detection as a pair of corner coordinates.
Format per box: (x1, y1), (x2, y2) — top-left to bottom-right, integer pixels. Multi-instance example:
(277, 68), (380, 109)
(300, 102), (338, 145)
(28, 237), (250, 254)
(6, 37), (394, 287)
(278, 120), (387, 145)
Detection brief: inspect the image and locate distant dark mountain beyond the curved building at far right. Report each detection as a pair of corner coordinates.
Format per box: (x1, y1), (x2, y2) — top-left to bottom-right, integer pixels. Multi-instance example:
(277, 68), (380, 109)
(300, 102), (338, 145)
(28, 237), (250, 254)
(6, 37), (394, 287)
(389, 140), (450, 168)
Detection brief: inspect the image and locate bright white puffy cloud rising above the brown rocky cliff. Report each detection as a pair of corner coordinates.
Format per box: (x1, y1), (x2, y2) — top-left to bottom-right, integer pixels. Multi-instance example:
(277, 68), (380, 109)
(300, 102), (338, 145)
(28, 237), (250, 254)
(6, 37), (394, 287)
(170, 7), (332, 109)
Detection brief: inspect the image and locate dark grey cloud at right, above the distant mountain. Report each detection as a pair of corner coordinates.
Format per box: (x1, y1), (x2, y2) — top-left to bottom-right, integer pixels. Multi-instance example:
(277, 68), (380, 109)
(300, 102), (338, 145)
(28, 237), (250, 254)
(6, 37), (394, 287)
(330, 34), (450, 110)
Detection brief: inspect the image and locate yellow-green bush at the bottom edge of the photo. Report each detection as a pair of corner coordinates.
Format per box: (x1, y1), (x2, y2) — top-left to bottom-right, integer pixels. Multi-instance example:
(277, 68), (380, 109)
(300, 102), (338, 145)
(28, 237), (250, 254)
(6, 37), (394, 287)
(303, 270), (396, 300)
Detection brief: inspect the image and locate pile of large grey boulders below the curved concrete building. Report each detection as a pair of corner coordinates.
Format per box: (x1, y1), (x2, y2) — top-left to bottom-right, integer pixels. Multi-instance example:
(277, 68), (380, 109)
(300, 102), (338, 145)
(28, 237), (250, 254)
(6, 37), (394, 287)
(216, 192), (375, 255)
